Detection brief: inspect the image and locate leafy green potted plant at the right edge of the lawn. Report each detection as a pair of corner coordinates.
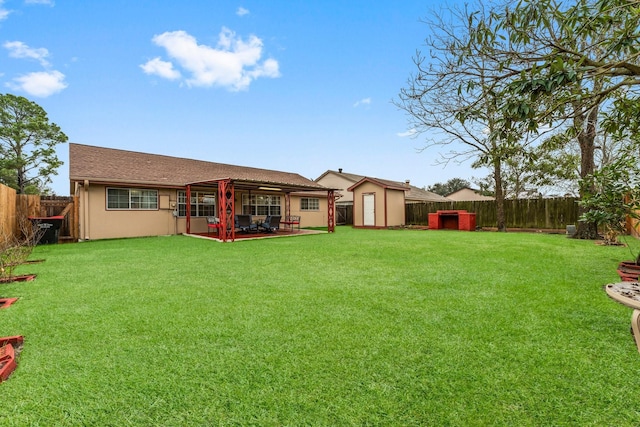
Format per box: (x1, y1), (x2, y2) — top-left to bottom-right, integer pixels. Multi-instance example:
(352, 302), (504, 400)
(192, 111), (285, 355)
(579, 153), (640, 281)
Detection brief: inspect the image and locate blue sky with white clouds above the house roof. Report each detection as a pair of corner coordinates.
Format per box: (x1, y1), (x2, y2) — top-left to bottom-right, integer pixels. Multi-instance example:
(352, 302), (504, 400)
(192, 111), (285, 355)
(0, 0), (485, 195)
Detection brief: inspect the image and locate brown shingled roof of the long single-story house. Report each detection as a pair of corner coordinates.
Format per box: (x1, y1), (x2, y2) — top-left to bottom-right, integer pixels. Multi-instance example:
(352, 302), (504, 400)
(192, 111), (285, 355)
(69, 144), (328, 191)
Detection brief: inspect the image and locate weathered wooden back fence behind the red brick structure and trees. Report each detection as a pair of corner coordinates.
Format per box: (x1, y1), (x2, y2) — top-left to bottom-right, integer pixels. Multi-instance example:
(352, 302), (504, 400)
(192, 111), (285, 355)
(405, 197), (579, 230)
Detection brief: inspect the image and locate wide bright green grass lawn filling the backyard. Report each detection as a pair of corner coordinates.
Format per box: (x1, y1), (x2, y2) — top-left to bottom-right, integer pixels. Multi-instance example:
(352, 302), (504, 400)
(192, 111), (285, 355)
(0, 227), (640, 426)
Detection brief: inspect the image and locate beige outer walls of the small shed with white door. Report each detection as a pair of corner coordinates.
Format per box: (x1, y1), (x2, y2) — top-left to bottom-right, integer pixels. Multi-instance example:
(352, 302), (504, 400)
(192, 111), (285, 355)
(353, 182), (405, 227)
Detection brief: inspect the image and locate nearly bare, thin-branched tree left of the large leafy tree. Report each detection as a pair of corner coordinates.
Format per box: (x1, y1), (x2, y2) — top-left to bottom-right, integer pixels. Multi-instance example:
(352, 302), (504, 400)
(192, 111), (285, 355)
(395, 2), (532, 231)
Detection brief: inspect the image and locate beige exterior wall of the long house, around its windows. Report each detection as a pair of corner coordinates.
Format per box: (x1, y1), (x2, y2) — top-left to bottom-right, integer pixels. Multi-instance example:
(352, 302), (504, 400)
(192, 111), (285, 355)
(76, 184), (328, 240)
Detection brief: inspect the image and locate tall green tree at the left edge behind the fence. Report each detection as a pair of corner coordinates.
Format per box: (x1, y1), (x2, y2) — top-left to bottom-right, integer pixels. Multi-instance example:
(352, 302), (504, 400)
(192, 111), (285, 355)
(0, 94), (68, 194)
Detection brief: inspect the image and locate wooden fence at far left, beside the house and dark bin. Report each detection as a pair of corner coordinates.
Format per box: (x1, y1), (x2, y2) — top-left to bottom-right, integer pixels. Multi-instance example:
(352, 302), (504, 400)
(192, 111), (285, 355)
(0, 184), (79, 242)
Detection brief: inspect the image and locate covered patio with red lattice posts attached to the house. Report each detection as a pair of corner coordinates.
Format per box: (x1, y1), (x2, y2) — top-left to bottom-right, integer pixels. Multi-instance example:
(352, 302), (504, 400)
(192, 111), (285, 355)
(186, 178), (335, 242)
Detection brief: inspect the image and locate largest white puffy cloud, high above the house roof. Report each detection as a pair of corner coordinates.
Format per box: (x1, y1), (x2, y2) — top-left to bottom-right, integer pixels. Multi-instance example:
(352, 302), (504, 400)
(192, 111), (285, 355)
(141, 27), (280, 91)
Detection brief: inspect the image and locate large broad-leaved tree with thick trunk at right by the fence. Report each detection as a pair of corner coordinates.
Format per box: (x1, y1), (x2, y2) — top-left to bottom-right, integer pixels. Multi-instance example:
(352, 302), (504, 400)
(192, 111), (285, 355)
(469, 0), (640, 238)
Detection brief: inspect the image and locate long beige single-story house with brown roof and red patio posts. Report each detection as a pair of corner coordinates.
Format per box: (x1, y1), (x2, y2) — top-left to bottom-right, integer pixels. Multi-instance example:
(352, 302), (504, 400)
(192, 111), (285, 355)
(69, 143), (335, 241)
